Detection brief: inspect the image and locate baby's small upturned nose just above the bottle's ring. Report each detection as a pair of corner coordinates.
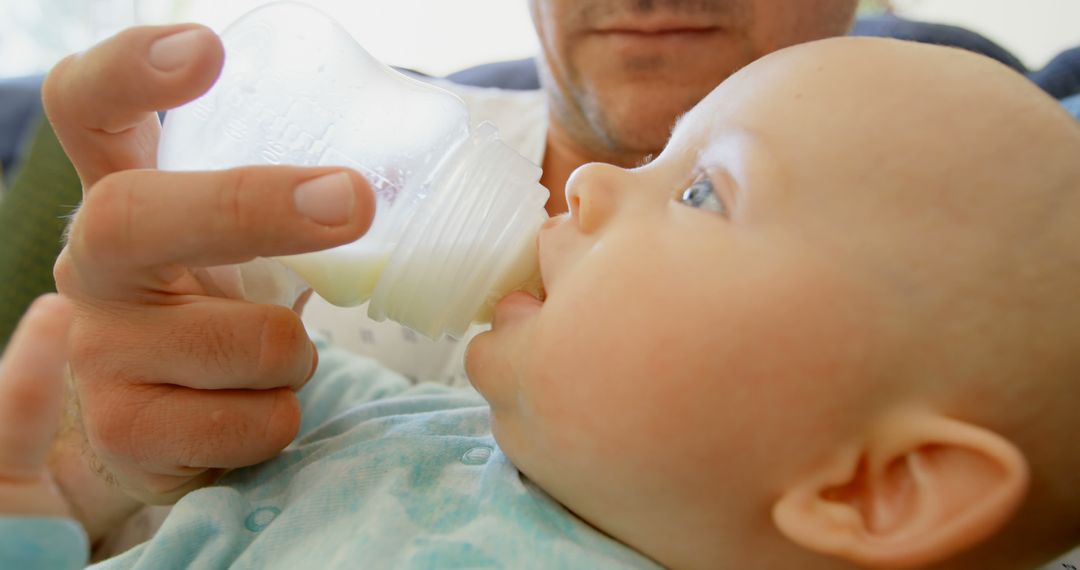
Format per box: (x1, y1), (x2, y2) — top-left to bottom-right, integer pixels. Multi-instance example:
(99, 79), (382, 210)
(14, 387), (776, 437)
(566, 163), (627, 233)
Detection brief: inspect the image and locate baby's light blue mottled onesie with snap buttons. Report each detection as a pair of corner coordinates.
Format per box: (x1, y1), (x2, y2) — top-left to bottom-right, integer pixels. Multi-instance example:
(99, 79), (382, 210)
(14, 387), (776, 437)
(0, 347), (657, 570)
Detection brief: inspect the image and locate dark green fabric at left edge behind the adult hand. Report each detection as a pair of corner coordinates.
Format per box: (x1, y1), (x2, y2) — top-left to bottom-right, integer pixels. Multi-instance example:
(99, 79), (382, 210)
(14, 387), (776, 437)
(0, 119), (82, 349)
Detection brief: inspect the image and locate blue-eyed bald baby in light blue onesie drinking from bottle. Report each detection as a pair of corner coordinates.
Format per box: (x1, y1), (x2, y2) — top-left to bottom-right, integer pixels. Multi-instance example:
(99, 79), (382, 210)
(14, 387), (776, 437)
(0, 38), (1080, 570)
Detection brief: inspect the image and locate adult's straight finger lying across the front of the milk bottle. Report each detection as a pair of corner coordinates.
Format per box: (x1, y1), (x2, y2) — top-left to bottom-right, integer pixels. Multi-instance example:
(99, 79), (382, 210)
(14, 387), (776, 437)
(63, 165), (375, 299)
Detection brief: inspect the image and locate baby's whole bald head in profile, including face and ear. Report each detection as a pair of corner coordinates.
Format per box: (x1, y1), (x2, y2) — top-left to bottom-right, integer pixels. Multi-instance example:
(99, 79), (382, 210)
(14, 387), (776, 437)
(470, 38), (1080, 570)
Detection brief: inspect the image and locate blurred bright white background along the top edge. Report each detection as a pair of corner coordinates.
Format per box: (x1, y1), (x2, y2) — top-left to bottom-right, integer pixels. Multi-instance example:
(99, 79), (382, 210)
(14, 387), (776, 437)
(0, 0), (1080, 77)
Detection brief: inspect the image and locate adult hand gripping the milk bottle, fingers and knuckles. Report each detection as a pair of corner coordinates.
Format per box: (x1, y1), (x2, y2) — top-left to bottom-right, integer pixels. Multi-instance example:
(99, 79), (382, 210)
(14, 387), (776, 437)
(43, 25), (375, 503)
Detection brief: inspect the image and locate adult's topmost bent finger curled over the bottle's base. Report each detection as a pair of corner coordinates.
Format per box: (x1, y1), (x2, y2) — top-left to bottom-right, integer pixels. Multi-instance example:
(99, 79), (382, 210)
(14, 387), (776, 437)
(42, 24), (225, 188)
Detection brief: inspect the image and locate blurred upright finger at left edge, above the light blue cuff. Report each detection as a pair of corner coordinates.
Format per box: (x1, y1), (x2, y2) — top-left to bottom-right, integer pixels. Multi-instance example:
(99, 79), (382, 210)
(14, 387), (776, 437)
(0, 295), (71, 480)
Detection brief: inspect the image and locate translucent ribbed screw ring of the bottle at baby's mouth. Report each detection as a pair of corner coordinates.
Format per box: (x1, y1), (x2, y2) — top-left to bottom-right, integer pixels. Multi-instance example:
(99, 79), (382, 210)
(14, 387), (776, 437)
(368, 123), (549, 338)
